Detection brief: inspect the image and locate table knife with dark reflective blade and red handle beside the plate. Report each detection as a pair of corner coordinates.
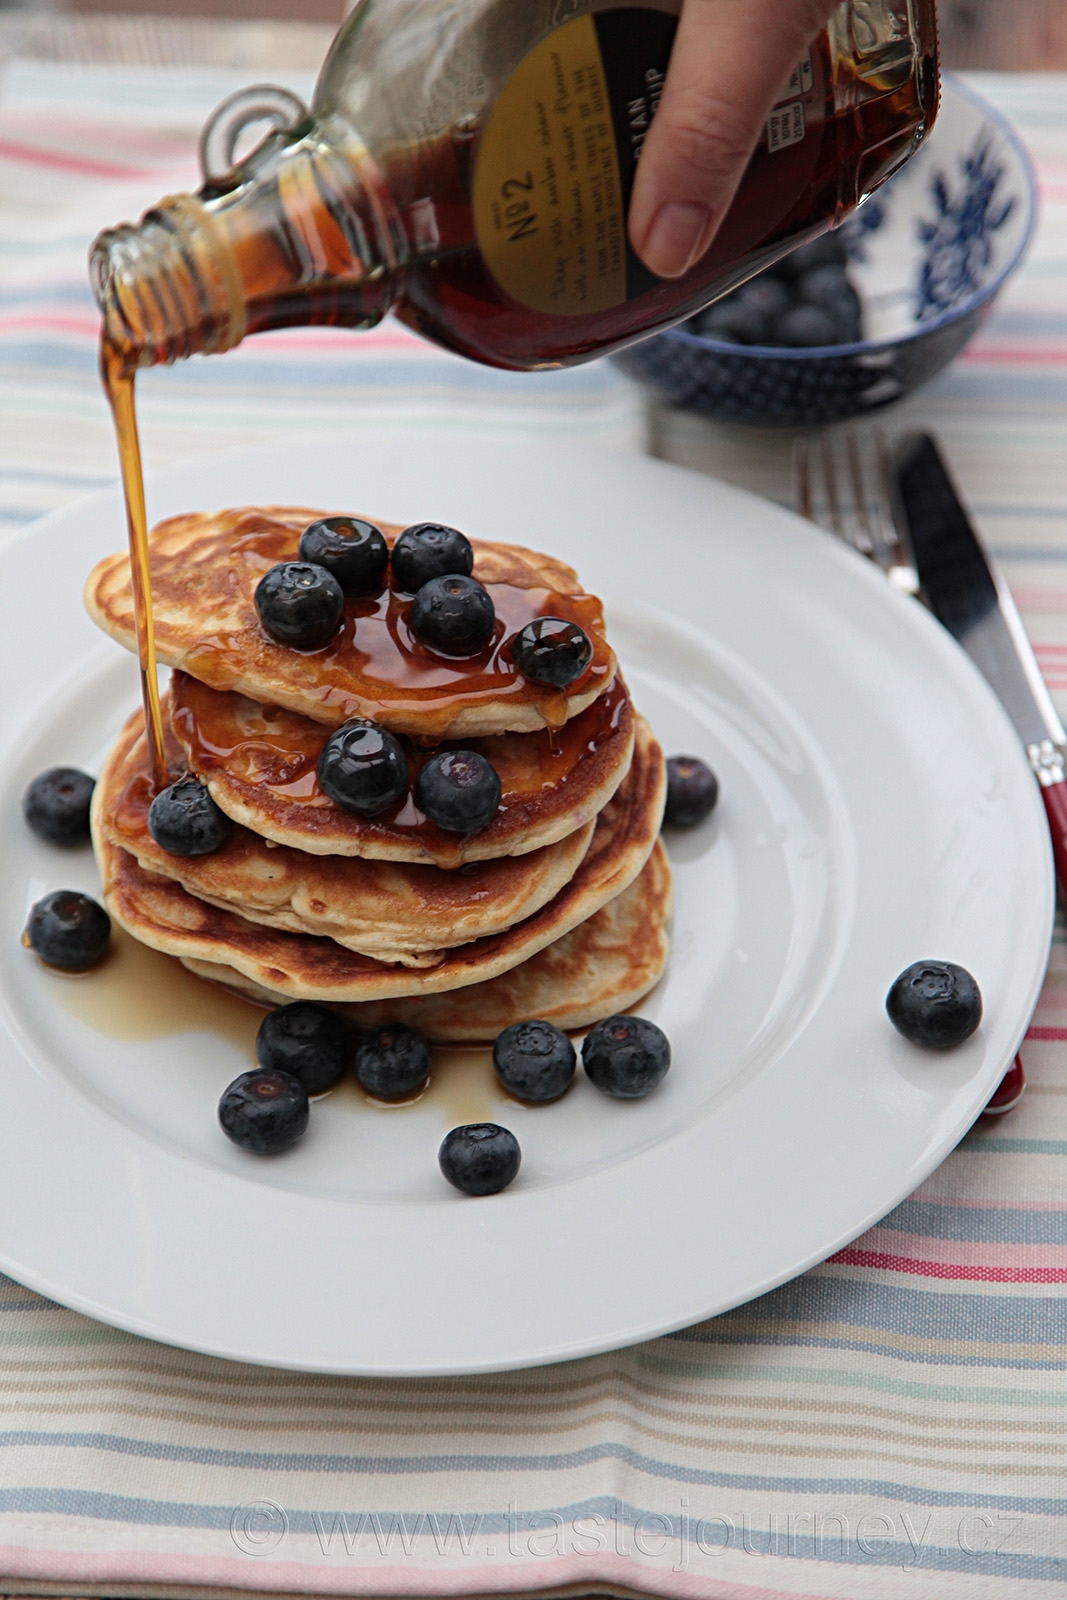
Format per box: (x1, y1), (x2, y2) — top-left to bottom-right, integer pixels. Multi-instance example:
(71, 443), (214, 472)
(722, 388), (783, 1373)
(891, 434), (1067, 896)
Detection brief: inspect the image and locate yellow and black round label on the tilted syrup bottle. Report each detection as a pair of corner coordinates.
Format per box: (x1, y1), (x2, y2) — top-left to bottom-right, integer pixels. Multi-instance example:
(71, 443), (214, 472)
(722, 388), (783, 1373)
(472, 8), (677, 317)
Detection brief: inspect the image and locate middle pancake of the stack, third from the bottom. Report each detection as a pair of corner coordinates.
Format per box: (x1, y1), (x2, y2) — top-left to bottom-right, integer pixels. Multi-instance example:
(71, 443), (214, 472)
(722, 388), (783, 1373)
(93, 710), (595, 966)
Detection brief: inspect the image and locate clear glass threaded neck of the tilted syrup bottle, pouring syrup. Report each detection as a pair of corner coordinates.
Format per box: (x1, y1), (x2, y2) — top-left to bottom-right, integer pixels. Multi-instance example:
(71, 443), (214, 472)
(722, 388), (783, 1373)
(90, 128), (399, 371)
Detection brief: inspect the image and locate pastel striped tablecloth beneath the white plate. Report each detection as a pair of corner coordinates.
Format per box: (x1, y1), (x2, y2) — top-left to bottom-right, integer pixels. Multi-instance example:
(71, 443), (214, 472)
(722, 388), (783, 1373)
(0, 37), (1067, 1600)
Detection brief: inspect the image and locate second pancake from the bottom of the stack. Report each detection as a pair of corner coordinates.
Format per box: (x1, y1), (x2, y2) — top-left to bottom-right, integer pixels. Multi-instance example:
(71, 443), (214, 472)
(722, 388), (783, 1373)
(93, 718), (665, 1002)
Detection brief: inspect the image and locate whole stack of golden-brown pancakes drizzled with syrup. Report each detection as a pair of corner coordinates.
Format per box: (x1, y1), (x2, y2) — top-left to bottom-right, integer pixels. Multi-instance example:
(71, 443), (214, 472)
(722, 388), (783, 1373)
(86, 507), (670, 1040)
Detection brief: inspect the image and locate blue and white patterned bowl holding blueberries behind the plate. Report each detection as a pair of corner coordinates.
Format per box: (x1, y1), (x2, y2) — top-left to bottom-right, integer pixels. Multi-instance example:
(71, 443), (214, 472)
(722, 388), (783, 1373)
(616, 77), (1037, 427)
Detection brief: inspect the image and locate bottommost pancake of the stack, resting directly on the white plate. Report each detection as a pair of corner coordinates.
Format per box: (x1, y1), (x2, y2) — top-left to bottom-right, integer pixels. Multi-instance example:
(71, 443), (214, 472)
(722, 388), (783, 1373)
(184, 842), (672, 1043)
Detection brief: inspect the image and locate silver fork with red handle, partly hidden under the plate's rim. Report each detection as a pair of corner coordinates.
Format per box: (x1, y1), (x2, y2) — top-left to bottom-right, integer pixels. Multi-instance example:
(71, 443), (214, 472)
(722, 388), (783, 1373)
(793, 427), (1027, 1117)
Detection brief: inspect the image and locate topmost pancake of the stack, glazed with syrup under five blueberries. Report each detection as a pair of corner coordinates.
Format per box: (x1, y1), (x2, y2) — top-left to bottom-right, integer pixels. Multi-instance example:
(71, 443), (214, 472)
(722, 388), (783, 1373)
(85, 506), (616, 739)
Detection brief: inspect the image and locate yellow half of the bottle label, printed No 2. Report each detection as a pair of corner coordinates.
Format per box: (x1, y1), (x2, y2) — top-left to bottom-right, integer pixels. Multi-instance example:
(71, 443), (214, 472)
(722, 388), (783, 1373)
(474, 16), (625, 317)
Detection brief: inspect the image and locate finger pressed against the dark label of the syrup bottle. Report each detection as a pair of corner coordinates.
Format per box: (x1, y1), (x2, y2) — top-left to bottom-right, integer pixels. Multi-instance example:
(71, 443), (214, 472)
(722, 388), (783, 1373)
(630, 0), (835, 278)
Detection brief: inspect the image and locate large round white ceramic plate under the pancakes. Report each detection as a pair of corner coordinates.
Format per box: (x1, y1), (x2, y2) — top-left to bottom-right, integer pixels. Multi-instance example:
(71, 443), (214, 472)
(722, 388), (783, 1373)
(0, 430), (1053, 1374)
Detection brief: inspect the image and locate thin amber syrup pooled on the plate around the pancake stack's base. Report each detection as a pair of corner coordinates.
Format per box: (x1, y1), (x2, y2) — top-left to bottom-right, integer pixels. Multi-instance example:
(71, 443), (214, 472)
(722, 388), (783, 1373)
(45, 928), (515, 1128)
